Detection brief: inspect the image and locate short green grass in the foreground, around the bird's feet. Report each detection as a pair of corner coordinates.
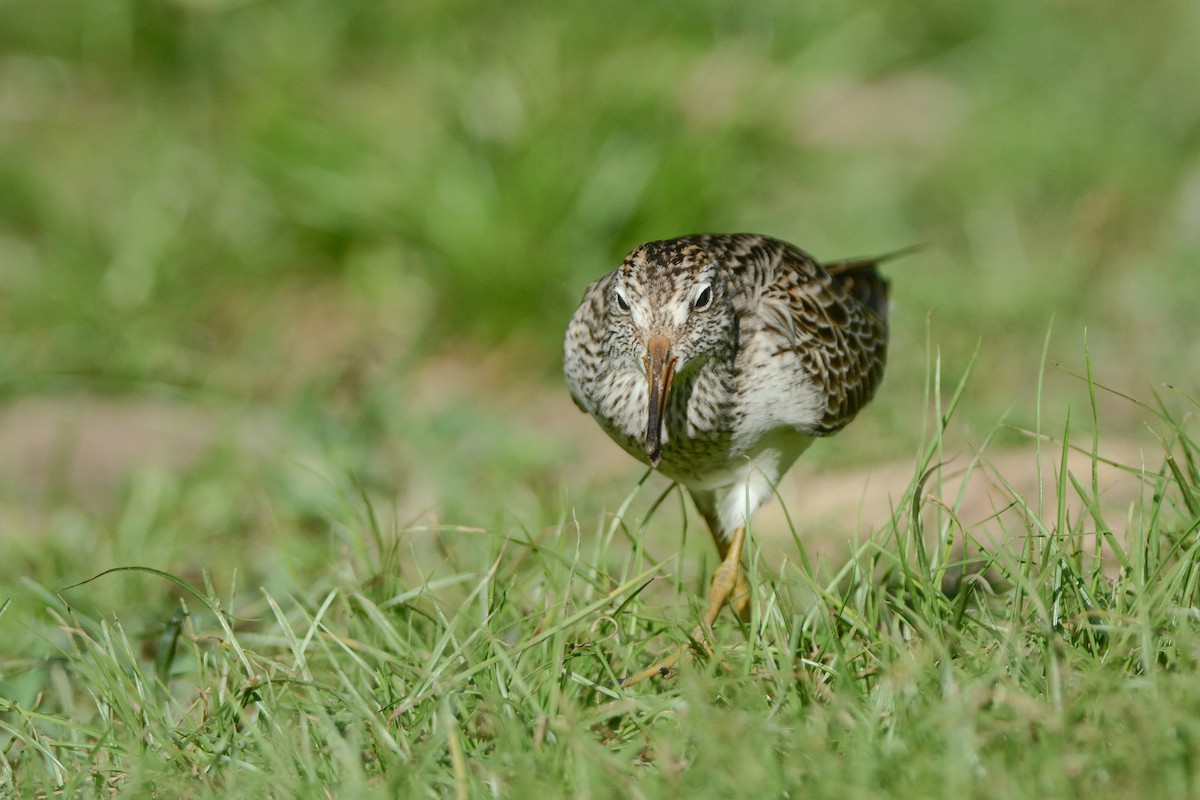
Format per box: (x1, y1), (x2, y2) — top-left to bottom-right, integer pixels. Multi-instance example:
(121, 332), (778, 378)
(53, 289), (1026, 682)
(7, 352), (1200, 798)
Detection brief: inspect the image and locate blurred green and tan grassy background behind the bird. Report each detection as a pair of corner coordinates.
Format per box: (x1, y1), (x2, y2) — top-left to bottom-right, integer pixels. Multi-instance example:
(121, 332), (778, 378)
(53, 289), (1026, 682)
(0, 0), (1200, 582)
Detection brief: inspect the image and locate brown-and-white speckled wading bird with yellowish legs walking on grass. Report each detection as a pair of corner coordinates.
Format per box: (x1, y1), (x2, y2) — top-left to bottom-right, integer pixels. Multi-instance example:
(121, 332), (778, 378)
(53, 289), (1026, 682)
(563, 234), (907, 686)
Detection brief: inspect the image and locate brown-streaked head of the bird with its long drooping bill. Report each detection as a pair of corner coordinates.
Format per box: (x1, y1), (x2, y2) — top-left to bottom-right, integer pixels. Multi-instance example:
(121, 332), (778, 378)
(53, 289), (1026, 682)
(605, 240), (737, 467)
